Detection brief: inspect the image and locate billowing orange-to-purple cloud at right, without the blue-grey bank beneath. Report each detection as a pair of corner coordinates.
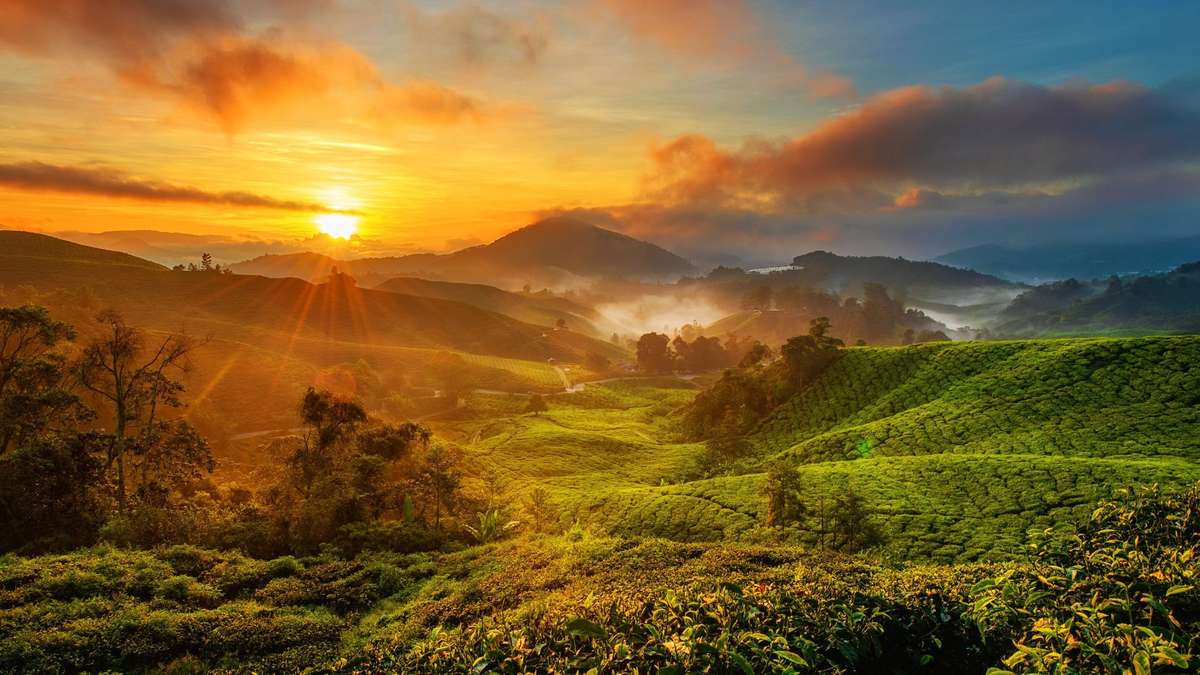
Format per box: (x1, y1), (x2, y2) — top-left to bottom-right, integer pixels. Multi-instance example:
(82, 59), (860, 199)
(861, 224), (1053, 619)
(644, 78), (1200, 214)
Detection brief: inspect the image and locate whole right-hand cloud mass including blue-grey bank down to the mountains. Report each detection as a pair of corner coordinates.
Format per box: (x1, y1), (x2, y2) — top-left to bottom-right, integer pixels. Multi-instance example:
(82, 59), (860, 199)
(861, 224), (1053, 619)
(540, 78), (1200, 263)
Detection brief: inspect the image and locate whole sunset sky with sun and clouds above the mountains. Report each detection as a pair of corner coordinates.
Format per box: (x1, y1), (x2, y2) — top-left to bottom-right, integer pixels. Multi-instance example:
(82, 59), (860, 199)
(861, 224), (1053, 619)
(0, 0), (1200, 264)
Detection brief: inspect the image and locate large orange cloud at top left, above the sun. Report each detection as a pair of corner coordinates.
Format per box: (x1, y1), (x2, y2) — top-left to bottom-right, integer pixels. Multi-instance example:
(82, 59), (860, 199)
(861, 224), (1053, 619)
(0, 0), (484, 135)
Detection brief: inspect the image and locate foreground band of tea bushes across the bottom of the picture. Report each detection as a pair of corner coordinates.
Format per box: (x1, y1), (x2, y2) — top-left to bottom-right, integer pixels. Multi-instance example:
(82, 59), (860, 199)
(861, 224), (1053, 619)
(0, 485), (1200, 673)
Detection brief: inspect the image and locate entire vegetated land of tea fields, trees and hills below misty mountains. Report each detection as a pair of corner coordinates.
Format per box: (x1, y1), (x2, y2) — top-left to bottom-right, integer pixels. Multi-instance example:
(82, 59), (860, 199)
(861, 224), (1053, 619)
(0, 230), (1200, 673)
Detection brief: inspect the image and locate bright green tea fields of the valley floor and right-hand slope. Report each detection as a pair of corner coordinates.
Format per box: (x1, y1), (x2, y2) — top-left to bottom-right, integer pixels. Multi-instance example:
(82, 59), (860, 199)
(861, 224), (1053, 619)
(456, 336), (1200, 561)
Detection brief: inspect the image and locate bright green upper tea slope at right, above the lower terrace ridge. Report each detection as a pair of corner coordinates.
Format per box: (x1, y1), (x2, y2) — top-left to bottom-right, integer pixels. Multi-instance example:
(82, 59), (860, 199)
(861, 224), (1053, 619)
(755, 338), (1200, 462)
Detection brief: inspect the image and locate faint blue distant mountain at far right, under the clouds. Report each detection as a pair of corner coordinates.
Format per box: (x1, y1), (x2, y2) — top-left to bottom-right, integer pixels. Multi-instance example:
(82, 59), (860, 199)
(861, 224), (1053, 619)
(936, 237), (1200, 283)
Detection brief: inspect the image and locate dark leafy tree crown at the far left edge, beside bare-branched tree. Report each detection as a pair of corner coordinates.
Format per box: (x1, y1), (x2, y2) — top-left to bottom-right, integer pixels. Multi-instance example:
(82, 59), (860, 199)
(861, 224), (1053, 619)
(0, 305), (91, 455)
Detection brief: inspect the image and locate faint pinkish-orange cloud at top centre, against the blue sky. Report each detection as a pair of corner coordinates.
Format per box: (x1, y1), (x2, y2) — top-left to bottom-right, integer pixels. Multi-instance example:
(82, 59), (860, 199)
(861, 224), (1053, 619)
(596, 0), (857, 98)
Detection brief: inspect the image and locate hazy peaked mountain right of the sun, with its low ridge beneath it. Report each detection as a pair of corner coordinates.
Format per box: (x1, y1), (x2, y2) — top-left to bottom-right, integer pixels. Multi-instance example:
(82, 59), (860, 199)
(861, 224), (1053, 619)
(233, 217), (695, 288)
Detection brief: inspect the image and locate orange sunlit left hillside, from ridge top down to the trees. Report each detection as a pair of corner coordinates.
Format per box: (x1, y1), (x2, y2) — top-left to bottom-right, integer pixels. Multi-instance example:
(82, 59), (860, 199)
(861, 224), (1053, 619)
(0, 232), (624, 429)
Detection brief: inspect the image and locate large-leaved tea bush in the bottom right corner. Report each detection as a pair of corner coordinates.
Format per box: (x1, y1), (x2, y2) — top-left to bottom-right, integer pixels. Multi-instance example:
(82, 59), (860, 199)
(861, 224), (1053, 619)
(972, 484), (1200, 674)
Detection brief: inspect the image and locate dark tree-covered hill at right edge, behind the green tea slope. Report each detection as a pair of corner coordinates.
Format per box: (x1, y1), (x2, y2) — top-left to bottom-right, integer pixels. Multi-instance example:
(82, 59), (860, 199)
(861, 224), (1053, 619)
(990, 262), (1200, 338)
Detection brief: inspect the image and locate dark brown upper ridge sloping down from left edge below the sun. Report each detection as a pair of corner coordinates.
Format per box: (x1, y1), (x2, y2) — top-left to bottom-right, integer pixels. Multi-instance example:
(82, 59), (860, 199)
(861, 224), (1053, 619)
(0, 231), (624, 360)
